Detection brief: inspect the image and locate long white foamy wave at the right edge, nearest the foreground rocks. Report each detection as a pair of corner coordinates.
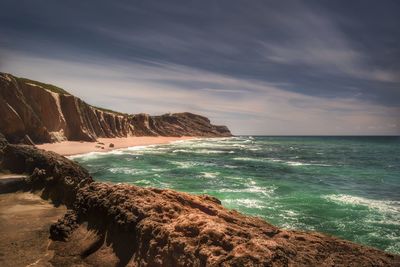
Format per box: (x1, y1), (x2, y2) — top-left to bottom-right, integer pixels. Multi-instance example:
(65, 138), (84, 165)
(325, 194), (400, 217)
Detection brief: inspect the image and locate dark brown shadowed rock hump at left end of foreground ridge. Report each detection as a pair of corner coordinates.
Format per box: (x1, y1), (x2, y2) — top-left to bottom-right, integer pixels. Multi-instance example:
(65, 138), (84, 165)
(0, 139), (93, 207)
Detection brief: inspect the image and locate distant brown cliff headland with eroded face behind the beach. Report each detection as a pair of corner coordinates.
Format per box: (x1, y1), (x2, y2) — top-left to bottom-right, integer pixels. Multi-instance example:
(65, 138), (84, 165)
(0, 73), (231, 143)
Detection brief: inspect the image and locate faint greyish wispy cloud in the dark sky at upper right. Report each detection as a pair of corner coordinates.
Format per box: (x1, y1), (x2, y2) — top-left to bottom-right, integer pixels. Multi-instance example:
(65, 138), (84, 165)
(261, 3), (400, 83)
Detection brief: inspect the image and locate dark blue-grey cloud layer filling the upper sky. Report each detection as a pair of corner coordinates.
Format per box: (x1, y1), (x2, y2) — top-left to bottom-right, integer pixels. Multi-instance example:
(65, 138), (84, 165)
(0, 0), (400, 134)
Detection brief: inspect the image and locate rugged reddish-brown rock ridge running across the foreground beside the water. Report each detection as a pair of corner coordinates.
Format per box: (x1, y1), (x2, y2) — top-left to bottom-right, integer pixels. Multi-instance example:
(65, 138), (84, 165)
(0, 135), (400, 266)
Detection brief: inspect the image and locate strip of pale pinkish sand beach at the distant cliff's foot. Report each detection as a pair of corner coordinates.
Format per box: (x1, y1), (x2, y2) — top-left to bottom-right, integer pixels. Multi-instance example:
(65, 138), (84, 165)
(37, 136), (195, 156)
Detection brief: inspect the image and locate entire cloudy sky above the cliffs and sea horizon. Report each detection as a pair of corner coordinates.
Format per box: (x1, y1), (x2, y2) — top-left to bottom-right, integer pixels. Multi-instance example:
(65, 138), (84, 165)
(0, 0), (400, 135)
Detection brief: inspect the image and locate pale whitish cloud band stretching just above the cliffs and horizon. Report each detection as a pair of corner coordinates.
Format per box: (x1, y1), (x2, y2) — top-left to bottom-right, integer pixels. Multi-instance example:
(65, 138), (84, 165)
(5, 48), (400, 134)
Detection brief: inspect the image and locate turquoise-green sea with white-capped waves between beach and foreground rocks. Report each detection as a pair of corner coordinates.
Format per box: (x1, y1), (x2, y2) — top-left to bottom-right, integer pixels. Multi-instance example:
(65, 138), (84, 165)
(73, 136), (400, 253)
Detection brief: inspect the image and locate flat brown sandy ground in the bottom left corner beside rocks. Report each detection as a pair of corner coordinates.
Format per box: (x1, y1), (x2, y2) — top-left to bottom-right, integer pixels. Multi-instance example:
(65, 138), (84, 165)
(0, 192), (66, 267)
